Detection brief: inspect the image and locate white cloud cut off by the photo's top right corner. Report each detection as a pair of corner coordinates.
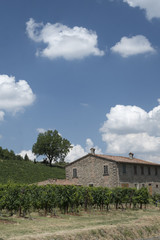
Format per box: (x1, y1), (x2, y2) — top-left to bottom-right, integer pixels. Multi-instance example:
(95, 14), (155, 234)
(123, 0), (160, 20)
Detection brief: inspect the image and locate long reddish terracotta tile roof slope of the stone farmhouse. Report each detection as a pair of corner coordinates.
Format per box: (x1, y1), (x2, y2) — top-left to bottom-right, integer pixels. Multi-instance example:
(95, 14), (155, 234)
(95, 154), (160, 166)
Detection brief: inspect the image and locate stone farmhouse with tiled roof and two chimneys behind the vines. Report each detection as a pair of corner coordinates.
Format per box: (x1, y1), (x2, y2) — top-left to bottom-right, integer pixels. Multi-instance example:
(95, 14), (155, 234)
(66, 148), (160, 194)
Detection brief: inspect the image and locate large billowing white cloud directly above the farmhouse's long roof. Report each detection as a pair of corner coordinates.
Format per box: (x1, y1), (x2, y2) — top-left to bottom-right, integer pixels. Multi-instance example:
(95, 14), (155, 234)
(100, 102), (160, 161)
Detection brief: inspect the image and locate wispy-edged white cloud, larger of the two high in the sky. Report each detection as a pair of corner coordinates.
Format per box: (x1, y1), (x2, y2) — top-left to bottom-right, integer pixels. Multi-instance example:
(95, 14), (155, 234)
(26, 18), (104, 60)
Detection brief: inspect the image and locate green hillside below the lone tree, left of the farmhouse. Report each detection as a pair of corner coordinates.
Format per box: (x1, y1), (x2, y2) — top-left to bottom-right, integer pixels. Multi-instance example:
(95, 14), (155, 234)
(0, 159), (65, 184)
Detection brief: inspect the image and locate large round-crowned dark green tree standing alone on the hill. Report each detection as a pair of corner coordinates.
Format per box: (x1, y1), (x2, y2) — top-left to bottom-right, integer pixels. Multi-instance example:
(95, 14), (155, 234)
(32, 130), (72, 166)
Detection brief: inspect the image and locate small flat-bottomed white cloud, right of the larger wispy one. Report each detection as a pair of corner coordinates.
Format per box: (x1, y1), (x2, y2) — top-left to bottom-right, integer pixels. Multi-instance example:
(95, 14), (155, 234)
(111, 35), (156, 57)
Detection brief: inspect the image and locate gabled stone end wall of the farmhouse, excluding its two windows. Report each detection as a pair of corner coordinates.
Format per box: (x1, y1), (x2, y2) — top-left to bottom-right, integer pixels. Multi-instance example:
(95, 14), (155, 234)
(66, 154), (118, 187)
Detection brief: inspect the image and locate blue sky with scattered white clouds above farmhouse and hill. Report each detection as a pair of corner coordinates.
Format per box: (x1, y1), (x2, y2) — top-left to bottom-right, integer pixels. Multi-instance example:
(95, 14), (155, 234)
(0, 0), (160, 162)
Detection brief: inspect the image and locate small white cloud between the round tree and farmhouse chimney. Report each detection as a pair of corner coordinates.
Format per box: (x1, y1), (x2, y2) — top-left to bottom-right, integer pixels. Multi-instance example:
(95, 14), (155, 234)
(65, 138), (102, 162)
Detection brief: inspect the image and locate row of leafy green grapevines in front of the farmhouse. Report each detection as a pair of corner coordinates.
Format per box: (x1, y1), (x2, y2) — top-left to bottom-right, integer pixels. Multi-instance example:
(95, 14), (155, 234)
(0, 184), (159, 217)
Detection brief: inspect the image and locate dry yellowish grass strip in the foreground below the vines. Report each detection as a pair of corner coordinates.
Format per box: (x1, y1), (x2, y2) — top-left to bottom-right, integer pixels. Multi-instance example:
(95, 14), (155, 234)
(0, 207), (160, 240)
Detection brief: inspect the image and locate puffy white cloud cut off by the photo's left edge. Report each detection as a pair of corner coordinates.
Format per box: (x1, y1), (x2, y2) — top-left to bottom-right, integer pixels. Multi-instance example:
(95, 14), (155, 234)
(0, 75), (35, 116)
